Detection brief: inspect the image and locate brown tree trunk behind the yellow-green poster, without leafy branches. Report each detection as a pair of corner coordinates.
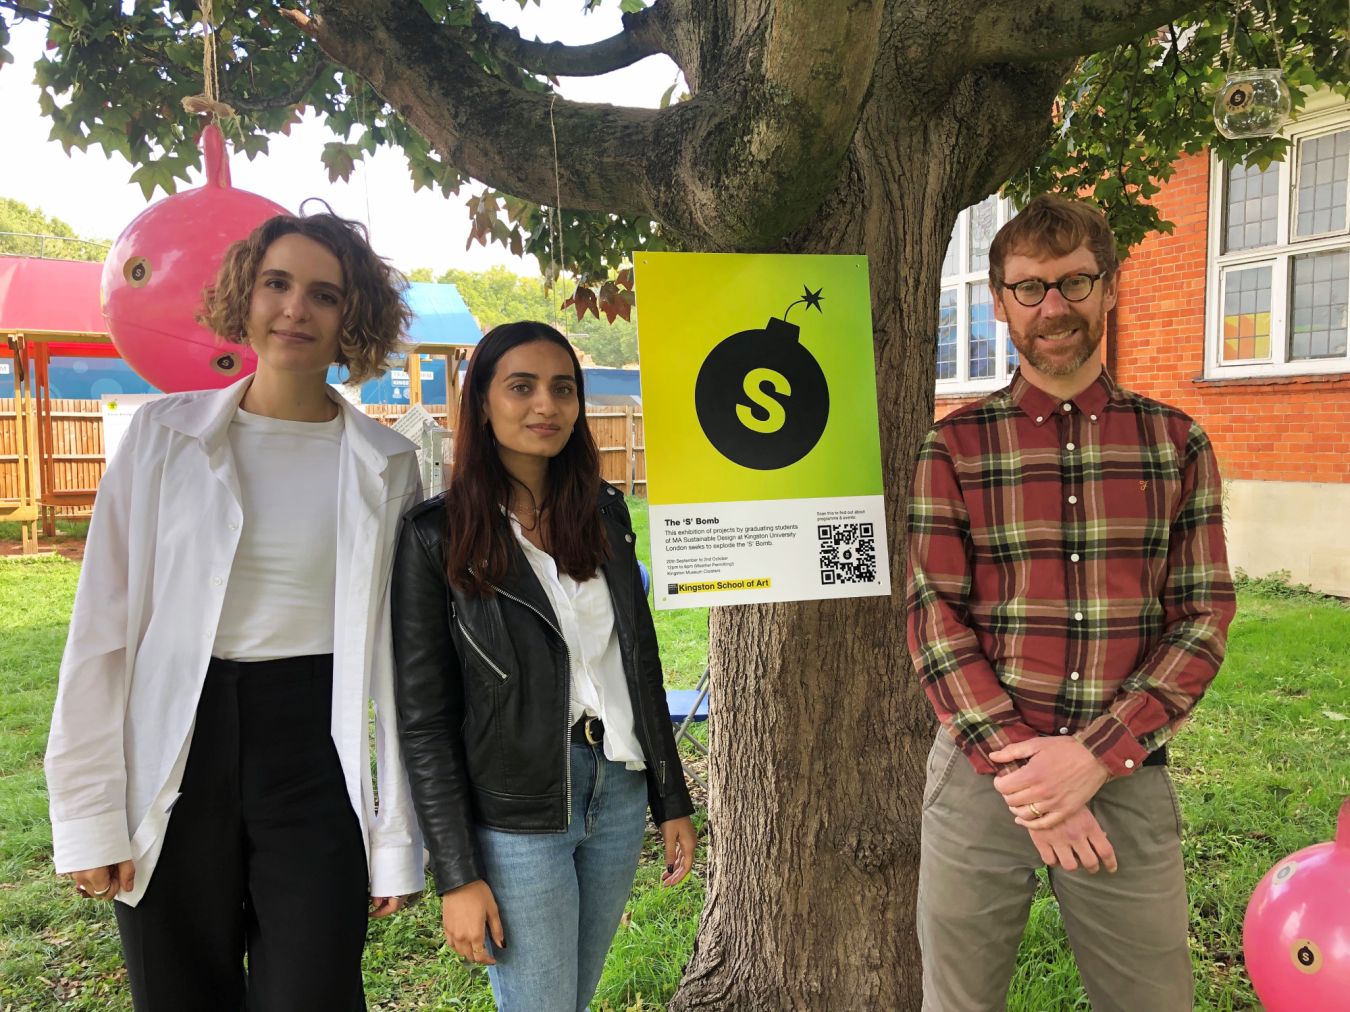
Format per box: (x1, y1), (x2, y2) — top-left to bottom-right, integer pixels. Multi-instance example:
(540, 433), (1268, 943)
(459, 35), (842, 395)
(671, 53), (1062, 1012)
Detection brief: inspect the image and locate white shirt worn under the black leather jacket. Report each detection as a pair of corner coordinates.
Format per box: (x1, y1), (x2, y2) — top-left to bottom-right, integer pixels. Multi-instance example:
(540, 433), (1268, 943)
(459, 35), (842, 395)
(508, 514), (647, 769)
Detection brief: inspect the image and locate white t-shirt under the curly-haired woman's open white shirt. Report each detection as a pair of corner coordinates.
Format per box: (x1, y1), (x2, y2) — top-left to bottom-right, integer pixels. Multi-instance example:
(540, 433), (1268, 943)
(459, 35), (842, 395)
(211, 409), (343, 661)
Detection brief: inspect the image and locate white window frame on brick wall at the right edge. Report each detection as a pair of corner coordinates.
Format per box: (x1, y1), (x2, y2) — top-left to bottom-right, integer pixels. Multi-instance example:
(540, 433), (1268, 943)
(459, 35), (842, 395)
(1204, 93), (1350, 379)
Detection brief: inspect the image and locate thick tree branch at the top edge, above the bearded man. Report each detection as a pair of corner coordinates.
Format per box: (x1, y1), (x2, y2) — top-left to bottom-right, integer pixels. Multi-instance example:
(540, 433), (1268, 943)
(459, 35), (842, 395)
(960, 0), (1197, 66)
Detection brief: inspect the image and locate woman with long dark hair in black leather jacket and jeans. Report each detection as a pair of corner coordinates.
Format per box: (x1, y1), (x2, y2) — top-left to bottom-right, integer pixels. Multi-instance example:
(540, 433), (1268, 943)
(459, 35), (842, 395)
(393, 322), (695, 1012)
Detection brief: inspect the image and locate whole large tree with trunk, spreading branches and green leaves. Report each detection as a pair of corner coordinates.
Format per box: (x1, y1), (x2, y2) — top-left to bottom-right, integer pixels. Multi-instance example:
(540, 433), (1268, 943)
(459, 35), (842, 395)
(0, 0), (1347, 1009)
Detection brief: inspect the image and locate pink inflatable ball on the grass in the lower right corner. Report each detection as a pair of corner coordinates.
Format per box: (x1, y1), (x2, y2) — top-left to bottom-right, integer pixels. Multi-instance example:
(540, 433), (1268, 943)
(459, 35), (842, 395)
(1242, 797), (1350, 1012)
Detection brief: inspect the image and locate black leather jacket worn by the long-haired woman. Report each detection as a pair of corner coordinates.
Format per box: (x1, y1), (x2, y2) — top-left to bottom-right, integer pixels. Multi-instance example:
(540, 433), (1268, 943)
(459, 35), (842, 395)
(392, 483), (694, 893)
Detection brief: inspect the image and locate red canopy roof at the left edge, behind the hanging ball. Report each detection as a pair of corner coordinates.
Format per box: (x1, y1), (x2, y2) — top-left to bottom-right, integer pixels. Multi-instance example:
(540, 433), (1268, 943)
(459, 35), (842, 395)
(0, 256), (116, 355)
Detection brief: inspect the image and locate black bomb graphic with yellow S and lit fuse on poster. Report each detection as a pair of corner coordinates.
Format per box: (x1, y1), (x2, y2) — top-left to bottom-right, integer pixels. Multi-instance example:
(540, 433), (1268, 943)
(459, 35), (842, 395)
(694, 287), (830, 471)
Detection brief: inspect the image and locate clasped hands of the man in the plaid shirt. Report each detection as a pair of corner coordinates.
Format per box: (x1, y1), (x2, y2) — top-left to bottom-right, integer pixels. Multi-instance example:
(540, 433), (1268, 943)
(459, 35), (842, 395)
(990, 737), (1116, 873)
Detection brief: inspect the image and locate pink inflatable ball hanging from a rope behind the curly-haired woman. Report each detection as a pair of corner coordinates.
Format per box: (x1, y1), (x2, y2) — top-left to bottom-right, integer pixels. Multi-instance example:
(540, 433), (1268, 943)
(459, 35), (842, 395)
(99, 124), (288, 391)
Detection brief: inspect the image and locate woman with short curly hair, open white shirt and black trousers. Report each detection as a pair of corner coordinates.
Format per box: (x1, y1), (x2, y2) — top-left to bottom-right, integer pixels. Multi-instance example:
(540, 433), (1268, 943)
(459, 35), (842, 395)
(46, 215), (423, 1012)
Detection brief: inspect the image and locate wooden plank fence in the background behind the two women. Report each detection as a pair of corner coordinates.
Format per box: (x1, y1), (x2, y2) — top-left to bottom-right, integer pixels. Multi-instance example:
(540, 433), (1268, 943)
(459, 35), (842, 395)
(0, 399), (647, 517)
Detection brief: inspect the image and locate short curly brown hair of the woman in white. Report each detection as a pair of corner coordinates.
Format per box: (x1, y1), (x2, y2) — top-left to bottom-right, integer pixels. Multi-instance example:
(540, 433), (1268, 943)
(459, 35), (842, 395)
(197, 213), (412, 386)
